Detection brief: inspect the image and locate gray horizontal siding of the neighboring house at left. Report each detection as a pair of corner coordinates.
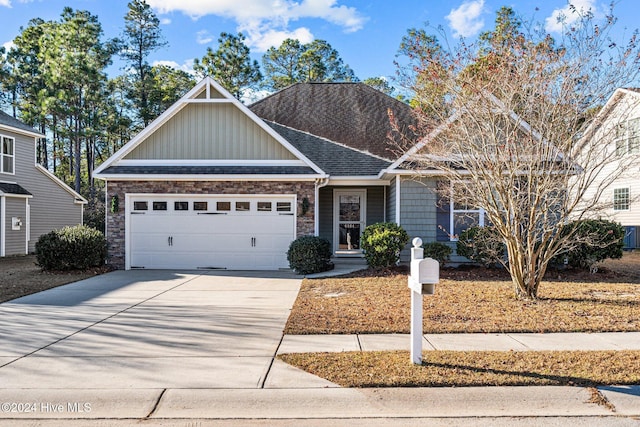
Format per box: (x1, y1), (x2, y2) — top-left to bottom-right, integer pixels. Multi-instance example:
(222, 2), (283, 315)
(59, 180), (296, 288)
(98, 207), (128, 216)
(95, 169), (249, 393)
(5, 129), (82, 252)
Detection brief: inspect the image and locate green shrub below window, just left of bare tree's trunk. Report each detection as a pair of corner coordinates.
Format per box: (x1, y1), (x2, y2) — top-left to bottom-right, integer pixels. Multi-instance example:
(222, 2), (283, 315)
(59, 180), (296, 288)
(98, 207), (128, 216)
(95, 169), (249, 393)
(456, 226), (506, 267)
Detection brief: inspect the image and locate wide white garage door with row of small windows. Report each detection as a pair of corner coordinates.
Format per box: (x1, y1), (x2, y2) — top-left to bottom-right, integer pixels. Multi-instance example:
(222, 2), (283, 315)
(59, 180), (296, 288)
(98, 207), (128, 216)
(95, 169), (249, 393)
(127, 195), (296, 270)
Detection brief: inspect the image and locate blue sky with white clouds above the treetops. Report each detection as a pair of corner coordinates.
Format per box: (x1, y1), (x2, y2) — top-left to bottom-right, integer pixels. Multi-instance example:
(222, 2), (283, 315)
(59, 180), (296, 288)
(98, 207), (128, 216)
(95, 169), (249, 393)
(0, 0), (640, 79)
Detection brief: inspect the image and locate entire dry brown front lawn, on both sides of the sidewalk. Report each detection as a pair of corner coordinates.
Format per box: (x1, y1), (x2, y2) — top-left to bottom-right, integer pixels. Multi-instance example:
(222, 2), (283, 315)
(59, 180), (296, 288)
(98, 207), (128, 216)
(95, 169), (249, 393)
(278, 252), (640, 390)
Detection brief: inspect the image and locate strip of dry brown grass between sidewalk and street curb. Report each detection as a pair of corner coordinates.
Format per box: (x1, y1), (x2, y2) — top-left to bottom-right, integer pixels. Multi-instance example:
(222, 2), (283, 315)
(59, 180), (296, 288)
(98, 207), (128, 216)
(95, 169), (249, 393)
(279, 351), (640, 387)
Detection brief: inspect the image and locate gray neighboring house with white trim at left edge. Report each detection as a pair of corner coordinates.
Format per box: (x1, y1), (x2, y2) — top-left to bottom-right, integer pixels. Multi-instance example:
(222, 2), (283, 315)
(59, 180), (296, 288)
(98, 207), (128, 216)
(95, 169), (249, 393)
(0, 111), (87, 256)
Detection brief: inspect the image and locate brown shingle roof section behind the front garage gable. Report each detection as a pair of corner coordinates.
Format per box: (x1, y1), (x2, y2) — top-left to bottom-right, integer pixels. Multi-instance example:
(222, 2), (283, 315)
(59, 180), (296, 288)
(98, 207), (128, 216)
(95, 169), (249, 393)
(249, 83), (414, 160)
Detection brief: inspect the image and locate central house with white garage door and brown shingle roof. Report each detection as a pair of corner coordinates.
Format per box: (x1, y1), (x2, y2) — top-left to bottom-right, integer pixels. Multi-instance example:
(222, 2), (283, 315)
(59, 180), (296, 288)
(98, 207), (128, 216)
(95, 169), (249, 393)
(94, 78), (492, 269)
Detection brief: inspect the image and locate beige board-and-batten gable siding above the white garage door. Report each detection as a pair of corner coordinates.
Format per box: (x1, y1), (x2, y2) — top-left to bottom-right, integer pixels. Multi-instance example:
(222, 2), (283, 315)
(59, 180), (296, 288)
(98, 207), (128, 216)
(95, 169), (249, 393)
(124, 103), (296, 160)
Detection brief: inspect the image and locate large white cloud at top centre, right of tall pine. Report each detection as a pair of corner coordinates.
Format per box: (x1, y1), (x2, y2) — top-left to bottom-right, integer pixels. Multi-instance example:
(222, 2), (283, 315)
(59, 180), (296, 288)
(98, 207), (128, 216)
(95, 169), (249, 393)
(144, 0), (367, 51)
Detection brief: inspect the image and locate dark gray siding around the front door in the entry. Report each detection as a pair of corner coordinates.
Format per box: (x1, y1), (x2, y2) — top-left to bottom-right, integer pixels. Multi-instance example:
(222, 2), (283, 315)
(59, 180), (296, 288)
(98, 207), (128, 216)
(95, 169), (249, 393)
(318, 186), (385, 247)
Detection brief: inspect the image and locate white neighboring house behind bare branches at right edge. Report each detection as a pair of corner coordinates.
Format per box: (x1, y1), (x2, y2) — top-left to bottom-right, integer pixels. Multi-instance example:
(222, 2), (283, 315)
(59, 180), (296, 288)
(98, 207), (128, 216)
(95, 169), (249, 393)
(585, 88), (640, 249)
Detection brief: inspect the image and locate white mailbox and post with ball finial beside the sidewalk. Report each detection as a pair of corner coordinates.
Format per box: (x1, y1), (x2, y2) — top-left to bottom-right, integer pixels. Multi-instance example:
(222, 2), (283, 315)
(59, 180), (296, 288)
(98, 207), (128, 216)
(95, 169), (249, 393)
(409, 237), (440, 365)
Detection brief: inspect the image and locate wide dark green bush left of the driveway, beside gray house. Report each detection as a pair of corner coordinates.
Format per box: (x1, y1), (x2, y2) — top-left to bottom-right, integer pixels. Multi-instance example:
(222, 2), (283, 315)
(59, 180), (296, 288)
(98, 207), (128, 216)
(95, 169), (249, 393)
(36, 225), (107, 270)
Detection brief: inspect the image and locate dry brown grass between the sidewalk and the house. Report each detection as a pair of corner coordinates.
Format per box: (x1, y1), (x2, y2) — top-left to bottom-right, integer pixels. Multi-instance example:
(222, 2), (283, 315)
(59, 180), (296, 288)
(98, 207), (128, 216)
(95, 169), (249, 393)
(285, 252), (640, 334)
